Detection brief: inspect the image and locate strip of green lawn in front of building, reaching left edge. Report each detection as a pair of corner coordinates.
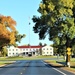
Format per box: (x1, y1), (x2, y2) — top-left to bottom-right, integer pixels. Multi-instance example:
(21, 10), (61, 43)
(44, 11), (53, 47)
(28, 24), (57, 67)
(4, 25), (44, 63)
(0, 56), (56, 66)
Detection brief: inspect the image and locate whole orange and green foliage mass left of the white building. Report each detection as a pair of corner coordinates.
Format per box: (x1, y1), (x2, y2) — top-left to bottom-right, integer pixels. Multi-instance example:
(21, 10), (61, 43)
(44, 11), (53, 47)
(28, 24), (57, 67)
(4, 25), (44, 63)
(0, 15), (25, 55)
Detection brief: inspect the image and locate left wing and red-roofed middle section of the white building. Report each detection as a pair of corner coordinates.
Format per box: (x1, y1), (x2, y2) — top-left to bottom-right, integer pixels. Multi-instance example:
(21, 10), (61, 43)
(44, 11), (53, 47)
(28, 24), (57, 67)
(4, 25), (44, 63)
(7, 46), (40, 57)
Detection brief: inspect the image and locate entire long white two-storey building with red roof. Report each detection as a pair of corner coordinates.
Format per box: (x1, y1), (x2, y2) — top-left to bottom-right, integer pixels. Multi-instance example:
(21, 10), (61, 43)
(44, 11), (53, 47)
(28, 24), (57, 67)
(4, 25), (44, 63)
(7, 46), (53, 56)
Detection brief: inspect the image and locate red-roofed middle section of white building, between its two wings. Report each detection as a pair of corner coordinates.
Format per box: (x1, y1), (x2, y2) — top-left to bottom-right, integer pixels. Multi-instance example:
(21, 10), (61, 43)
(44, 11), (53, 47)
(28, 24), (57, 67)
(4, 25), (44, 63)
(18, 46), (42, 56)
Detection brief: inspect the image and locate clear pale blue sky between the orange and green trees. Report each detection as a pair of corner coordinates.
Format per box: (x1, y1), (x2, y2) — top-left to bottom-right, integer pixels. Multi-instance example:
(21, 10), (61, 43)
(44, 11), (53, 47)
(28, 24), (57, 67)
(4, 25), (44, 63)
(0, 0), (52, 45)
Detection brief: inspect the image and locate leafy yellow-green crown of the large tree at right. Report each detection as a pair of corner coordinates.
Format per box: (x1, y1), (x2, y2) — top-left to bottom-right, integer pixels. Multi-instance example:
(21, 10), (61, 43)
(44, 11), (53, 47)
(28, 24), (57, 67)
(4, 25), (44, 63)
(32, 0), (75, 65)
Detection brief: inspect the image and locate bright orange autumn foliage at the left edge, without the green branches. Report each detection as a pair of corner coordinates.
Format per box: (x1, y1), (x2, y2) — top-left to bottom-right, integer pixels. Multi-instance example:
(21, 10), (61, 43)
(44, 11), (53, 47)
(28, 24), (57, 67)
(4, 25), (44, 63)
(0, 15), (16, 47)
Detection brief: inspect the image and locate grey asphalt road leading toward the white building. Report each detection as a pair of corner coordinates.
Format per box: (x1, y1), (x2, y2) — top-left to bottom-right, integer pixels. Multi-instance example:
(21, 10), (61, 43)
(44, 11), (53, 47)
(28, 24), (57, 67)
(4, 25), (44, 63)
(0, 60), (75, 75)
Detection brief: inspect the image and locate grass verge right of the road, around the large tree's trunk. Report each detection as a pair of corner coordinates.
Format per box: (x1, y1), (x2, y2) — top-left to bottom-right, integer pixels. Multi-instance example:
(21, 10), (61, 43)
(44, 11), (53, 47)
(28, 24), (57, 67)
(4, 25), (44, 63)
(45, 58), (75, 73)
